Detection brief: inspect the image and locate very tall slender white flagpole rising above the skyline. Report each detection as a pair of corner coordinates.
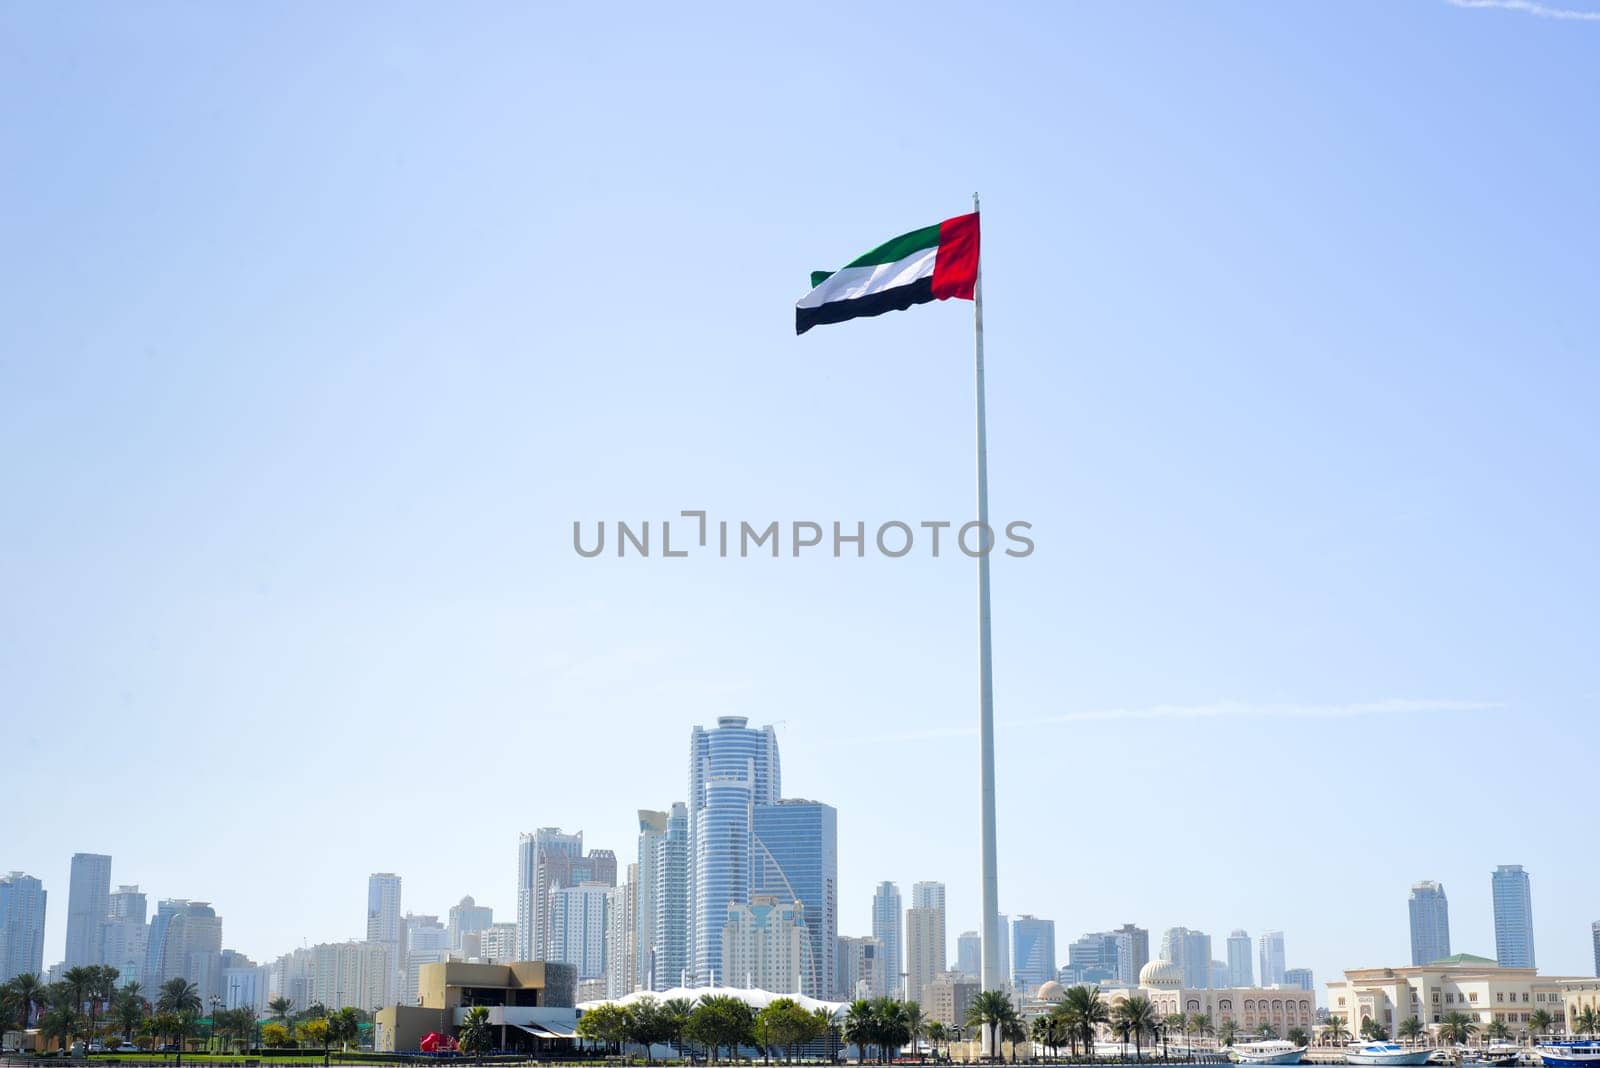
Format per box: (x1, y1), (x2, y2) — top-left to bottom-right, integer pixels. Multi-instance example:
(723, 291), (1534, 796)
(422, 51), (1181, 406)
(973, 193), (1005, 990)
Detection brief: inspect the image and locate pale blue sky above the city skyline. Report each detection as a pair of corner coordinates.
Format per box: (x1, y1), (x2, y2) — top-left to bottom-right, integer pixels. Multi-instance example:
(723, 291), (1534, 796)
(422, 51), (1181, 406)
(0, 0), (1600, 980)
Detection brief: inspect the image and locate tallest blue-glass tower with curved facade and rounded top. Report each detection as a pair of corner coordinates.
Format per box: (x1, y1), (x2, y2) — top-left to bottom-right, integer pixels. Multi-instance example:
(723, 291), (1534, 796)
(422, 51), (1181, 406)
(688, 716), (782, 985)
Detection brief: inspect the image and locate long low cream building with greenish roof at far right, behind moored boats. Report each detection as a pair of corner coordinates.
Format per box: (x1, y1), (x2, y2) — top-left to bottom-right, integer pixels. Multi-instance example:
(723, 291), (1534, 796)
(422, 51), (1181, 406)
(1328, 953), (1586, 1038)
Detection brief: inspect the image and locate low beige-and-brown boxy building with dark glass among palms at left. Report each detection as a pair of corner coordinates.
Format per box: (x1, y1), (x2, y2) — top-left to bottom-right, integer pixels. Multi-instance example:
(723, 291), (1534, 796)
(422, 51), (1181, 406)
(373, 961), (578, 1054)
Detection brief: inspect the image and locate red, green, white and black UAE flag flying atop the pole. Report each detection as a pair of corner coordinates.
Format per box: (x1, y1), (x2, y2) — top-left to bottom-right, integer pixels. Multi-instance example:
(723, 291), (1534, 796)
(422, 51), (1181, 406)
(795, 211), (978, 334)
